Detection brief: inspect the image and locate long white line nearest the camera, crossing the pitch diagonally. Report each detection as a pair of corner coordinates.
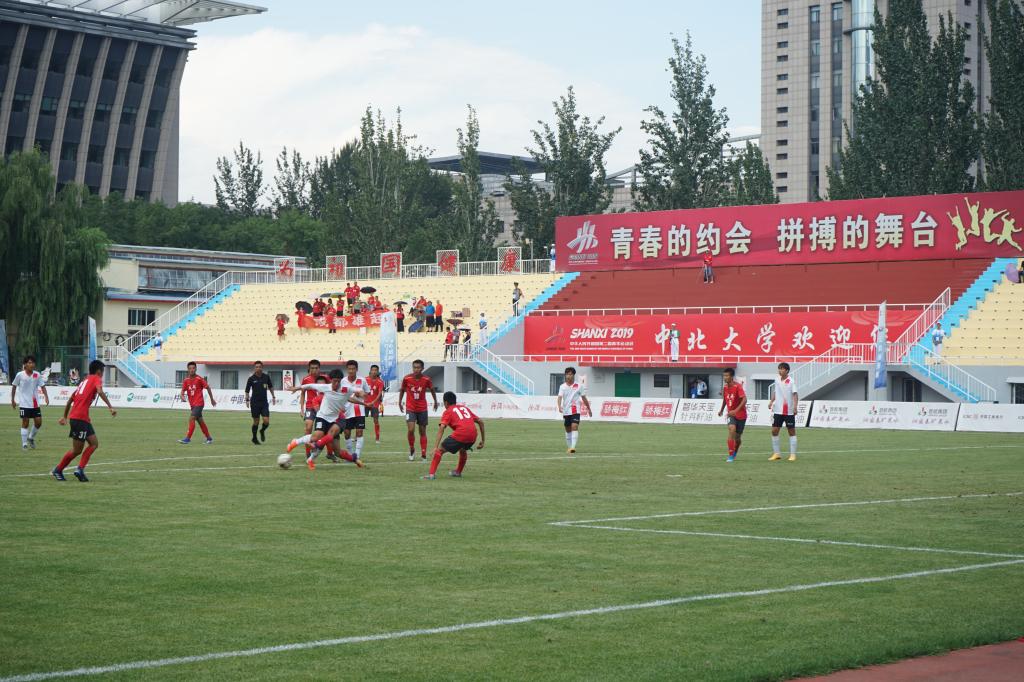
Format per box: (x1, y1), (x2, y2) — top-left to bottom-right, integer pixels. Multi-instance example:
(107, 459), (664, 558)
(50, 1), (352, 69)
(0, 559), (1024, 682)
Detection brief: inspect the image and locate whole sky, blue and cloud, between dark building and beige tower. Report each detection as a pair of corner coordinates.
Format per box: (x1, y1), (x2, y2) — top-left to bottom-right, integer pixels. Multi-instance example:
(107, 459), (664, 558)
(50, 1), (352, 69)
(179, 0), (761, 202)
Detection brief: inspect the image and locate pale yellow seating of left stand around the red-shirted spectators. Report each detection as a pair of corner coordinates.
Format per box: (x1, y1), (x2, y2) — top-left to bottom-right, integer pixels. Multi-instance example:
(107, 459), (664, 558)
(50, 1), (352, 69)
(139, 273), (557, 364)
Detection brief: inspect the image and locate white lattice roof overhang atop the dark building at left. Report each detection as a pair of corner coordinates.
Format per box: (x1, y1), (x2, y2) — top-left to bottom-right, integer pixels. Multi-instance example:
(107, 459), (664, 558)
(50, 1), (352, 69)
(22, 0), (266, 27)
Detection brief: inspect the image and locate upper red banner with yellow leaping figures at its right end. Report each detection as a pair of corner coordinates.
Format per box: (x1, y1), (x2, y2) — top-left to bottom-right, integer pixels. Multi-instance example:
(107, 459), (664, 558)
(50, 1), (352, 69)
(555, 191), (1024, 271)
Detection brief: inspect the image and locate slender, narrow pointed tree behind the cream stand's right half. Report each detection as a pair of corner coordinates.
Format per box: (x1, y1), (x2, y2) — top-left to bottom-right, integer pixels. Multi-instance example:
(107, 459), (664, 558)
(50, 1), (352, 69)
(450, 106), (502, 261)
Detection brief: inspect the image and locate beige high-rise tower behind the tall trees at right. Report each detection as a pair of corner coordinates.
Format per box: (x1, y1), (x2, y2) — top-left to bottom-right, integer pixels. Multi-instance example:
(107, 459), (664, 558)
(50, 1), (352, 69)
(761, 0), (990, 203)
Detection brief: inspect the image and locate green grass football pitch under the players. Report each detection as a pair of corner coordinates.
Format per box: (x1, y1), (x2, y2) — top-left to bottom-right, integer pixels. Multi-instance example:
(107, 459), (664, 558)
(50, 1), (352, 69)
(0, 408), (1024, 680)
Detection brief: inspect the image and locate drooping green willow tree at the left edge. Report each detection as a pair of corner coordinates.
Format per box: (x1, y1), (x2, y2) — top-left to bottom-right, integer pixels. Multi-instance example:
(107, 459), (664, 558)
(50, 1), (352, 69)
(0, 152), (108, 354)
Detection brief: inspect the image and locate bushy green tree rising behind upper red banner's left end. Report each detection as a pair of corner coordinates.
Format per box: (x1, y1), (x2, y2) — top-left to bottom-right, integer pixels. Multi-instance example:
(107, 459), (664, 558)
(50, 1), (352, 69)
(505, 86), (622, 245)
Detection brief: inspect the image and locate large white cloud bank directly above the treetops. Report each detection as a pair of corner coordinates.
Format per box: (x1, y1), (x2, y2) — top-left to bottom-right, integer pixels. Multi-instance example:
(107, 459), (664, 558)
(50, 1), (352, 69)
(179, 26), (644, 202)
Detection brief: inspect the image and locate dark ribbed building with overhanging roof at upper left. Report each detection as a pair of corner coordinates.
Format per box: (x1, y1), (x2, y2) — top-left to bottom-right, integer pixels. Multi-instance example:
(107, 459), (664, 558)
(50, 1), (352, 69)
(0, 0), (265, 206)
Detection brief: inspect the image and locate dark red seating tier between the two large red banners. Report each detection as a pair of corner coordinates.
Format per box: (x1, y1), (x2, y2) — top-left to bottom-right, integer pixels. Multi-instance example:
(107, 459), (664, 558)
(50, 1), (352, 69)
(542, 259), (992, 309)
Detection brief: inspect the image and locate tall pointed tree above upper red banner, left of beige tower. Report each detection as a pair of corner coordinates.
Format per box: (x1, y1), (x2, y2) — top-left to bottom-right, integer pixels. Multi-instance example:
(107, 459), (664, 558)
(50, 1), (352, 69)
(633, 33), (729, 211)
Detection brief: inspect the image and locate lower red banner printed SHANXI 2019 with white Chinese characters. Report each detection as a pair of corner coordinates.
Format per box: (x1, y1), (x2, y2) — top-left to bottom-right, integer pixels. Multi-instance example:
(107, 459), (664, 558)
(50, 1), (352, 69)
(523, 310), (921, 358)
